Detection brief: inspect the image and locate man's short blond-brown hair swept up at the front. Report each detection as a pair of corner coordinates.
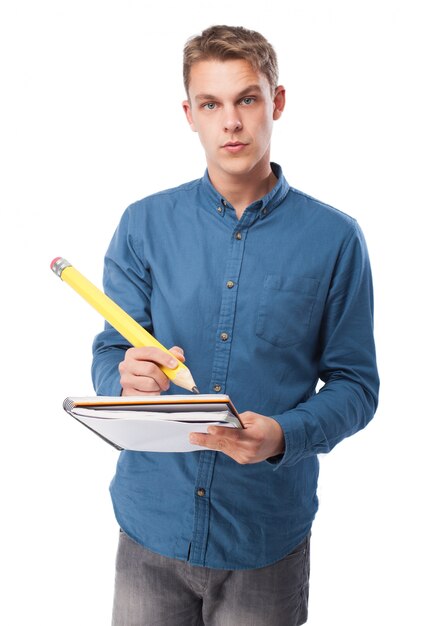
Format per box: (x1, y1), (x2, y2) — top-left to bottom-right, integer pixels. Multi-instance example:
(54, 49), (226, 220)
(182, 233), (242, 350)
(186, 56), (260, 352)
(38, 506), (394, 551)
(183, 26), (278, 94)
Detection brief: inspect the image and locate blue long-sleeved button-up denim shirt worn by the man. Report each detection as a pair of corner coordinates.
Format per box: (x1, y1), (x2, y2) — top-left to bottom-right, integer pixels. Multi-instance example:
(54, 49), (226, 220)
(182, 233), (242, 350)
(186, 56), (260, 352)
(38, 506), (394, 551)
(92, 164), (379, 569)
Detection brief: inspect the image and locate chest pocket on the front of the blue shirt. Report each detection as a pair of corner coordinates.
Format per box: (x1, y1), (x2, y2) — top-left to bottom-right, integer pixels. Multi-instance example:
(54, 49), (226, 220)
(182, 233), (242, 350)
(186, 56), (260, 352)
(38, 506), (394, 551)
(256, 274), (319, 348)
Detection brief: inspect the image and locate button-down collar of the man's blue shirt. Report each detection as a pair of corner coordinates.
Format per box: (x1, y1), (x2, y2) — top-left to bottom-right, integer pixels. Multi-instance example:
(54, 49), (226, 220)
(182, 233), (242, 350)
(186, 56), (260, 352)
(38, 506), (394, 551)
(201, 163), (290, 219)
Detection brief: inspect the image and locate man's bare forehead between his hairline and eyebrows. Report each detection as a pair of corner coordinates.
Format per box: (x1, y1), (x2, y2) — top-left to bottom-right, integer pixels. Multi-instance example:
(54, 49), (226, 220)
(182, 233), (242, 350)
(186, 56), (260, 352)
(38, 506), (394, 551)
(189, 59), (270, 97)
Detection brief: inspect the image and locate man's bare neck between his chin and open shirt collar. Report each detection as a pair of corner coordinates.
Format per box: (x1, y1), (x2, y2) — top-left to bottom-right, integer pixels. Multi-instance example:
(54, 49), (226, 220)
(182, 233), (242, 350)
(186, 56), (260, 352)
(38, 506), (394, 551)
(208, 164), (277, 219)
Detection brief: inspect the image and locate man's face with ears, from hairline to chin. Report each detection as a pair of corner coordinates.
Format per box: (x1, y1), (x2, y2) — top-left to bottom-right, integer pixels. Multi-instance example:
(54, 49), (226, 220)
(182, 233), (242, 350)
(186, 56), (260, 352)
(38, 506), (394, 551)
(183, 59), (285, 184)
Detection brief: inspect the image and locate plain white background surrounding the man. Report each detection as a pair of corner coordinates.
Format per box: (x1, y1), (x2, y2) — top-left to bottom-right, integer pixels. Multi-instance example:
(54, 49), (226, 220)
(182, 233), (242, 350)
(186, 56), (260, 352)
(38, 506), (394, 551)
(0, 0), (440, 626)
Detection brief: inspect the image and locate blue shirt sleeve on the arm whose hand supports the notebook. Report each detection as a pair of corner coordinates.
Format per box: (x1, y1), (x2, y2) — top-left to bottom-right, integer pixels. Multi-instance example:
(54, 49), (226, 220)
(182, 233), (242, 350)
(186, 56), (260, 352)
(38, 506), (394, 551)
(271, 223), (379, 469)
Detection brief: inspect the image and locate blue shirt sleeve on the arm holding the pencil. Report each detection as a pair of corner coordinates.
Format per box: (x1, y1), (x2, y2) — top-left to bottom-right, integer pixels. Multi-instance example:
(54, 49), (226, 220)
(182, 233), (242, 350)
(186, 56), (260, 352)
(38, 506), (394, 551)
(92, 207), (152, 396)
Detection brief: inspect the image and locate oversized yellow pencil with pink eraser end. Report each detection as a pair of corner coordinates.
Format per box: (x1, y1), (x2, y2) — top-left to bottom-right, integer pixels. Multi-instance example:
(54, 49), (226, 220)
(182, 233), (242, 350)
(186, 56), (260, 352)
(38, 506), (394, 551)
(50, 257), (199, 393)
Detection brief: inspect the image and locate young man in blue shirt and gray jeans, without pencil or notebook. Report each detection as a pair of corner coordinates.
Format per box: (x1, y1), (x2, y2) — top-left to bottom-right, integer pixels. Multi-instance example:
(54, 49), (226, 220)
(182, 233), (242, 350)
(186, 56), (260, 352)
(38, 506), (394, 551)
(93, 26), (378, 626)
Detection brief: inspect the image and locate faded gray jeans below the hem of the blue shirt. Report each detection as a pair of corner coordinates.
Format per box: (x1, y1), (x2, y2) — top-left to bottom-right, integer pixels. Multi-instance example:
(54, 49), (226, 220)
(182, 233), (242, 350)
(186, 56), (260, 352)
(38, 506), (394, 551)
(112, 532), (310, 626)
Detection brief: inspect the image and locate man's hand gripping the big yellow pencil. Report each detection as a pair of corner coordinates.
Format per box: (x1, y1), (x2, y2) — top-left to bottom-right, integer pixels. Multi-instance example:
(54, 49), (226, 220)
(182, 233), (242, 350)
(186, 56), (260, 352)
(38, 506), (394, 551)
(119, 346), (185, 396)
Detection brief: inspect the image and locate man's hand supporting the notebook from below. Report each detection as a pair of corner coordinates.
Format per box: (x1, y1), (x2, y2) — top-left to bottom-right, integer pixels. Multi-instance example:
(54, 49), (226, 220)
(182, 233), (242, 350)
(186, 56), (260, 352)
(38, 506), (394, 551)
(189, 411), (284, 464)
